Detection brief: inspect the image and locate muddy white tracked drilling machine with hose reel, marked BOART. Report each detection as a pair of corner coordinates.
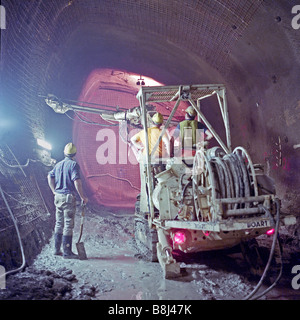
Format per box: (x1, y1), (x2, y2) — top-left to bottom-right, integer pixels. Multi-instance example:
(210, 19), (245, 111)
(45, 85), (295, 278)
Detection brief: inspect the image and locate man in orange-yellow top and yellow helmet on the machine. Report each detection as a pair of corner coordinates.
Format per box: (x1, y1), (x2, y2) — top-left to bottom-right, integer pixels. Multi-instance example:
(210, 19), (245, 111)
(130, 112), (170, 161)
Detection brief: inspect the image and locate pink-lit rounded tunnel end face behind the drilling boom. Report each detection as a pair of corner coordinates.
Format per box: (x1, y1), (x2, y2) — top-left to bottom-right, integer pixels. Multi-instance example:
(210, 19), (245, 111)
(73, 69), (188, 208)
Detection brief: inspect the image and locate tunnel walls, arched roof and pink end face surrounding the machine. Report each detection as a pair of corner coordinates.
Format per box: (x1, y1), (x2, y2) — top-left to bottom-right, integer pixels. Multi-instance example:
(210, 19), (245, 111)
(0, 0), (300, 300)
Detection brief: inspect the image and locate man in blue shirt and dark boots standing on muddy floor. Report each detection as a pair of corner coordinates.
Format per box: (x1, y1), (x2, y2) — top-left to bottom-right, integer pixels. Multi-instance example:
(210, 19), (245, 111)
(48, 143), (88, 259)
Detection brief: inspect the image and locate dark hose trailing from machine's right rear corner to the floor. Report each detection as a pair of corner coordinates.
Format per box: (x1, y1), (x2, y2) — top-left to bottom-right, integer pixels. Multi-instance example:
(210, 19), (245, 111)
(243, 199), (282, 300)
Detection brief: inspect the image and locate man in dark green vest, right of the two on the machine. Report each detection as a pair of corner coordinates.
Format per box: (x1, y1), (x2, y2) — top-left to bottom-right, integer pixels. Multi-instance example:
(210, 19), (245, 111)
(173, 106), (213, 150)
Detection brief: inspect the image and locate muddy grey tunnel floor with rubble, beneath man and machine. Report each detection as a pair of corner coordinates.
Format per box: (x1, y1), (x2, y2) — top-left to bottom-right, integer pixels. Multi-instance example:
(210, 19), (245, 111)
(0, 208), (300, 300)
